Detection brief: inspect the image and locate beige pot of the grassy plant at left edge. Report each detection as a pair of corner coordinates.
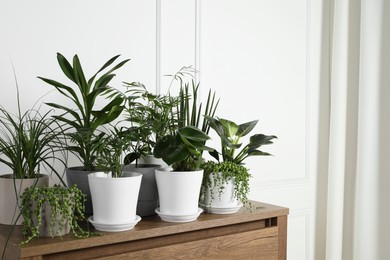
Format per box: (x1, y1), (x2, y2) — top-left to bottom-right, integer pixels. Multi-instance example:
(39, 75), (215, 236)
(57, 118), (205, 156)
(0, 174), (49, 225)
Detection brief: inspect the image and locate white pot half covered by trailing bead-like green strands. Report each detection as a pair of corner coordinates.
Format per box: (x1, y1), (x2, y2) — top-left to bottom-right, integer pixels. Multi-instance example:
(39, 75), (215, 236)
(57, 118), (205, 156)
(204, 173), (239, 208)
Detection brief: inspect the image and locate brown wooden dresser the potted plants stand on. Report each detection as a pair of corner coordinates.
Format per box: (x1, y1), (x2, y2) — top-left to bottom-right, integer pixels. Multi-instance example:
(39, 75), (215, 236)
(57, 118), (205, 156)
(0, 202), (288, 260)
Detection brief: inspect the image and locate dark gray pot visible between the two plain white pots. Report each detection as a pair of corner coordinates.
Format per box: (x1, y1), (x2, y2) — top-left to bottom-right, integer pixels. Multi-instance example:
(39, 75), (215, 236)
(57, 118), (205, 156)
(123, 164), (161, 217)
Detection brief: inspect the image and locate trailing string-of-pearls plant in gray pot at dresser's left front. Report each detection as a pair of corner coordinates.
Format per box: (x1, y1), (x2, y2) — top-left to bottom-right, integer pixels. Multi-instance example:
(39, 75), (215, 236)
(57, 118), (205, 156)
(20, 185), (90, 244)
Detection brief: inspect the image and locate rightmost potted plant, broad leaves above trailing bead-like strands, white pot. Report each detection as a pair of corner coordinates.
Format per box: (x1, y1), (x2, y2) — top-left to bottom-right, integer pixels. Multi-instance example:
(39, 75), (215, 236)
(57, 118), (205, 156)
(200, 116), (276, 214)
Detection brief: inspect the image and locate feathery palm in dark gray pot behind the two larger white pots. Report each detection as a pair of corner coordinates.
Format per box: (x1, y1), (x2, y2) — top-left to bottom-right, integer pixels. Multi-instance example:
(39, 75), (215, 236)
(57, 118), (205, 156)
(122, 82), (178, 217)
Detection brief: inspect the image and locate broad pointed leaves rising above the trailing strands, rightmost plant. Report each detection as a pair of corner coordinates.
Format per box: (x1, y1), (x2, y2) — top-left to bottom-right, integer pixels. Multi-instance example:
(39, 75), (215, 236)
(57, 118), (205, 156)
(205, 116), (277, 164)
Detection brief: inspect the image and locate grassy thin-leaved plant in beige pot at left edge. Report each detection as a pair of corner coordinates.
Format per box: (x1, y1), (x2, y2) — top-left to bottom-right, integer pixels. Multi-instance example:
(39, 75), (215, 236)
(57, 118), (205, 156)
(0, 85), (65, 225)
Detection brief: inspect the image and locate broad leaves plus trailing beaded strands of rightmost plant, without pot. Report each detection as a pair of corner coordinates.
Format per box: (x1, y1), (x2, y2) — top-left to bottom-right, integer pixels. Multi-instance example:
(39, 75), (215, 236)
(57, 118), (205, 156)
(201, 116), (277, 204)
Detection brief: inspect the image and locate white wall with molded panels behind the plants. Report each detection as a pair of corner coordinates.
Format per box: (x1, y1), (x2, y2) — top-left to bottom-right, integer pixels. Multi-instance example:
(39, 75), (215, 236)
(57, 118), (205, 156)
(0, 0), (322, 260)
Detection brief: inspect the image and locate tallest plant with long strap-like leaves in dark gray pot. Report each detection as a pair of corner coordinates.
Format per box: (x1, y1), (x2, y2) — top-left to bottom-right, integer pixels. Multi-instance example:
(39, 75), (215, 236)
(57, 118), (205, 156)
(38, 53), (129, 215)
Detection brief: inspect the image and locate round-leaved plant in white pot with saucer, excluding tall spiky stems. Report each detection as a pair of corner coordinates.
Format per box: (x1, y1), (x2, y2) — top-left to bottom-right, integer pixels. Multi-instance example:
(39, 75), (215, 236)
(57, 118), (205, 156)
(154, 126), (212, 222)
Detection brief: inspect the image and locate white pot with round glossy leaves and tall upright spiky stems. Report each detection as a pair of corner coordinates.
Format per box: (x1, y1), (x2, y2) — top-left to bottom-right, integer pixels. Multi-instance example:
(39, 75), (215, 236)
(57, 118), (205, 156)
(154, 76), (218, 222)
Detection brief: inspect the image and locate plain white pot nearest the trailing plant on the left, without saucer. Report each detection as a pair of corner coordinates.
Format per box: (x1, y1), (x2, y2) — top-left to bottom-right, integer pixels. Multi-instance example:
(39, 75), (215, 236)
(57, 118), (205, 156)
(88, 172), (142, 224)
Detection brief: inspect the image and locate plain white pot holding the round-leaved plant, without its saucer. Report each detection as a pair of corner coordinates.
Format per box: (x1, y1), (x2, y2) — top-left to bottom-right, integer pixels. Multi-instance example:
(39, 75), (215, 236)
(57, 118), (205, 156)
(156, 170), (203, 216)
